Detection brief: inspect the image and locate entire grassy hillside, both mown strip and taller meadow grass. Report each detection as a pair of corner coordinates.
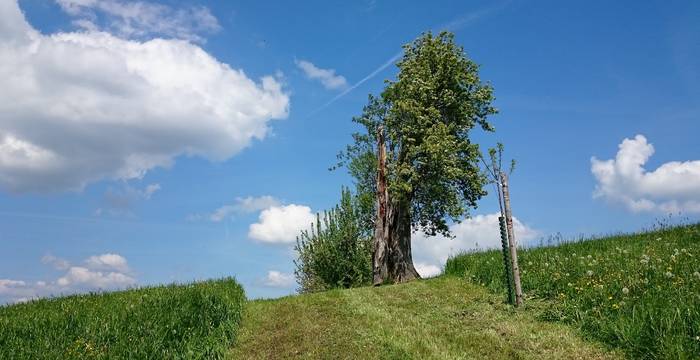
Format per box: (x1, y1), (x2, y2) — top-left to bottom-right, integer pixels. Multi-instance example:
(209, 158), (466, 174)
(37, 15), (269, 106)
(0, 225), (700, 359)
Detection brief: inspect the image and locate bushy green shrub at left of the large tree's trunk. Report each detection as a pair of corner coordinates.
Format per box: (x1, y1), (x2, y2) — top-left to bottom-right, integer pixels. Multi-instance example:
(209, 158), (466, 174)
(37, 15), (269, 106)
(294, 188), (372, 292)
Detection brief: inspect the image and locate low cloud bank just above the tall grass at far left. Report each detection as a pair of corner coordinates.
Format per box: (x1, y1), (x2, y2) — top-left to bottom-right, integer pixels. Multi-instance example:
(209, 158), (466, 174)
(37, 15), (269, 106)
(0, 253), (137, 303)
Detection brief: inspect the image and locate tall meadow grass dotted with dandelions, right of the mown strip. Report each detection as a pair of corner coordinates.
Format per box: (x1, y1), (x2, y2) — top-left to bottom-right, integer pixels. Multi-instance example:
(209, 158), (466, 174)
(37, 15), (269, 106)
(445, 225), (700, 359)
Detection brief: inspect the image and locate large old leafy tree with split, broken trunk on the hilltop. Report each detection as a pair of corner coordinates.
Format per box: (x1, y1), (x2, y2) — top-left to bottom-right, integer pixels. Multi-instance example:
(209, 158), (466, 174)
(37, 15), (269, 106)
(340, 32), (496, 285)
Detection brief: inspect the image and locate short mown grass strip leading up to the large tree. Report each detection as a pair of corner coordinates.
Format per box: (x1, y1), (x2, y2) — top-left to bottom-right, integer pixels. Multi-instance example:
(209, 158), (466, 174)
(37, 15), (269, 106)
(230, 277), (617, 359)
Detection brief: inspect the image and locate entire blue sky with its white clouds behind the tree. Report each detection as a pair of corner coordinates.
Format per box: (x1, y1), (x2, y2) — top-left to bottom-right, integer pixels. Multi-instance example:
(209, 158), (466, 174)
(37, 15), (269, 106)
(0, 0), (700, 302)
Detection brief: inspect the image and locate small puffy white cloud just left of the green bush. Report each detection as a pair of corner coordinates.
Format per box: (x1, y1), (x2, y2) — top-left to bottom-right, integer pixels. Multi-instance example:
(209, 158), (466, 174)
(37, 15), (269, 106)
(248, 204), (316, 244)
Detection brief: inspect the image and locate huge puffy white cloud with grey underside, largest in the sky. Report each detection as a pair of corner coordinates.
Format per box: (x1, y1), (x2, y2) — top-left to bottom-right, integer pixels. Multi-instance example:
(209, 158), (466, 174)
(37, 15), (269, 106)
(0, 0), (289, 192)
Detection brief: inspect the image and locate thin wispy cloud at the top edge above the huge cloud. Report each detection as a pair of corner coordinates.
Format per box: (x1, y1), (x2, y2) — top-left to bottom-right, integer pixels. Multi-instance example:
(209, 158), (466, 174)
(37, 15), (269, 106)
(56, 0), (221, 42)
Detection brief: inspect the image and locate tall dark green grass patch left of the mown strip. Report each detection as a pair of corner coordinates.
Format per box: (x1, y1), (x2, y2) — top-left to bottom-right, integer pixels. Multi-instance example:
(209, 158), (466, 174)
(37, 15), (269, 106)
(0, 279), (245, 359)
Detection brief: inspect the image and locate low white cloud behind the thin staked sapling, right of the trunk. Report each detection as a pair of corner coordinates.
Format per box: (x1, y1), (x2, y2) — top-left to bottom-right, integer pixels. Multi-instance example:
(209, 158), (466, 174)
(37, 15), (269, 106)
(412, 213), (539, 273)
